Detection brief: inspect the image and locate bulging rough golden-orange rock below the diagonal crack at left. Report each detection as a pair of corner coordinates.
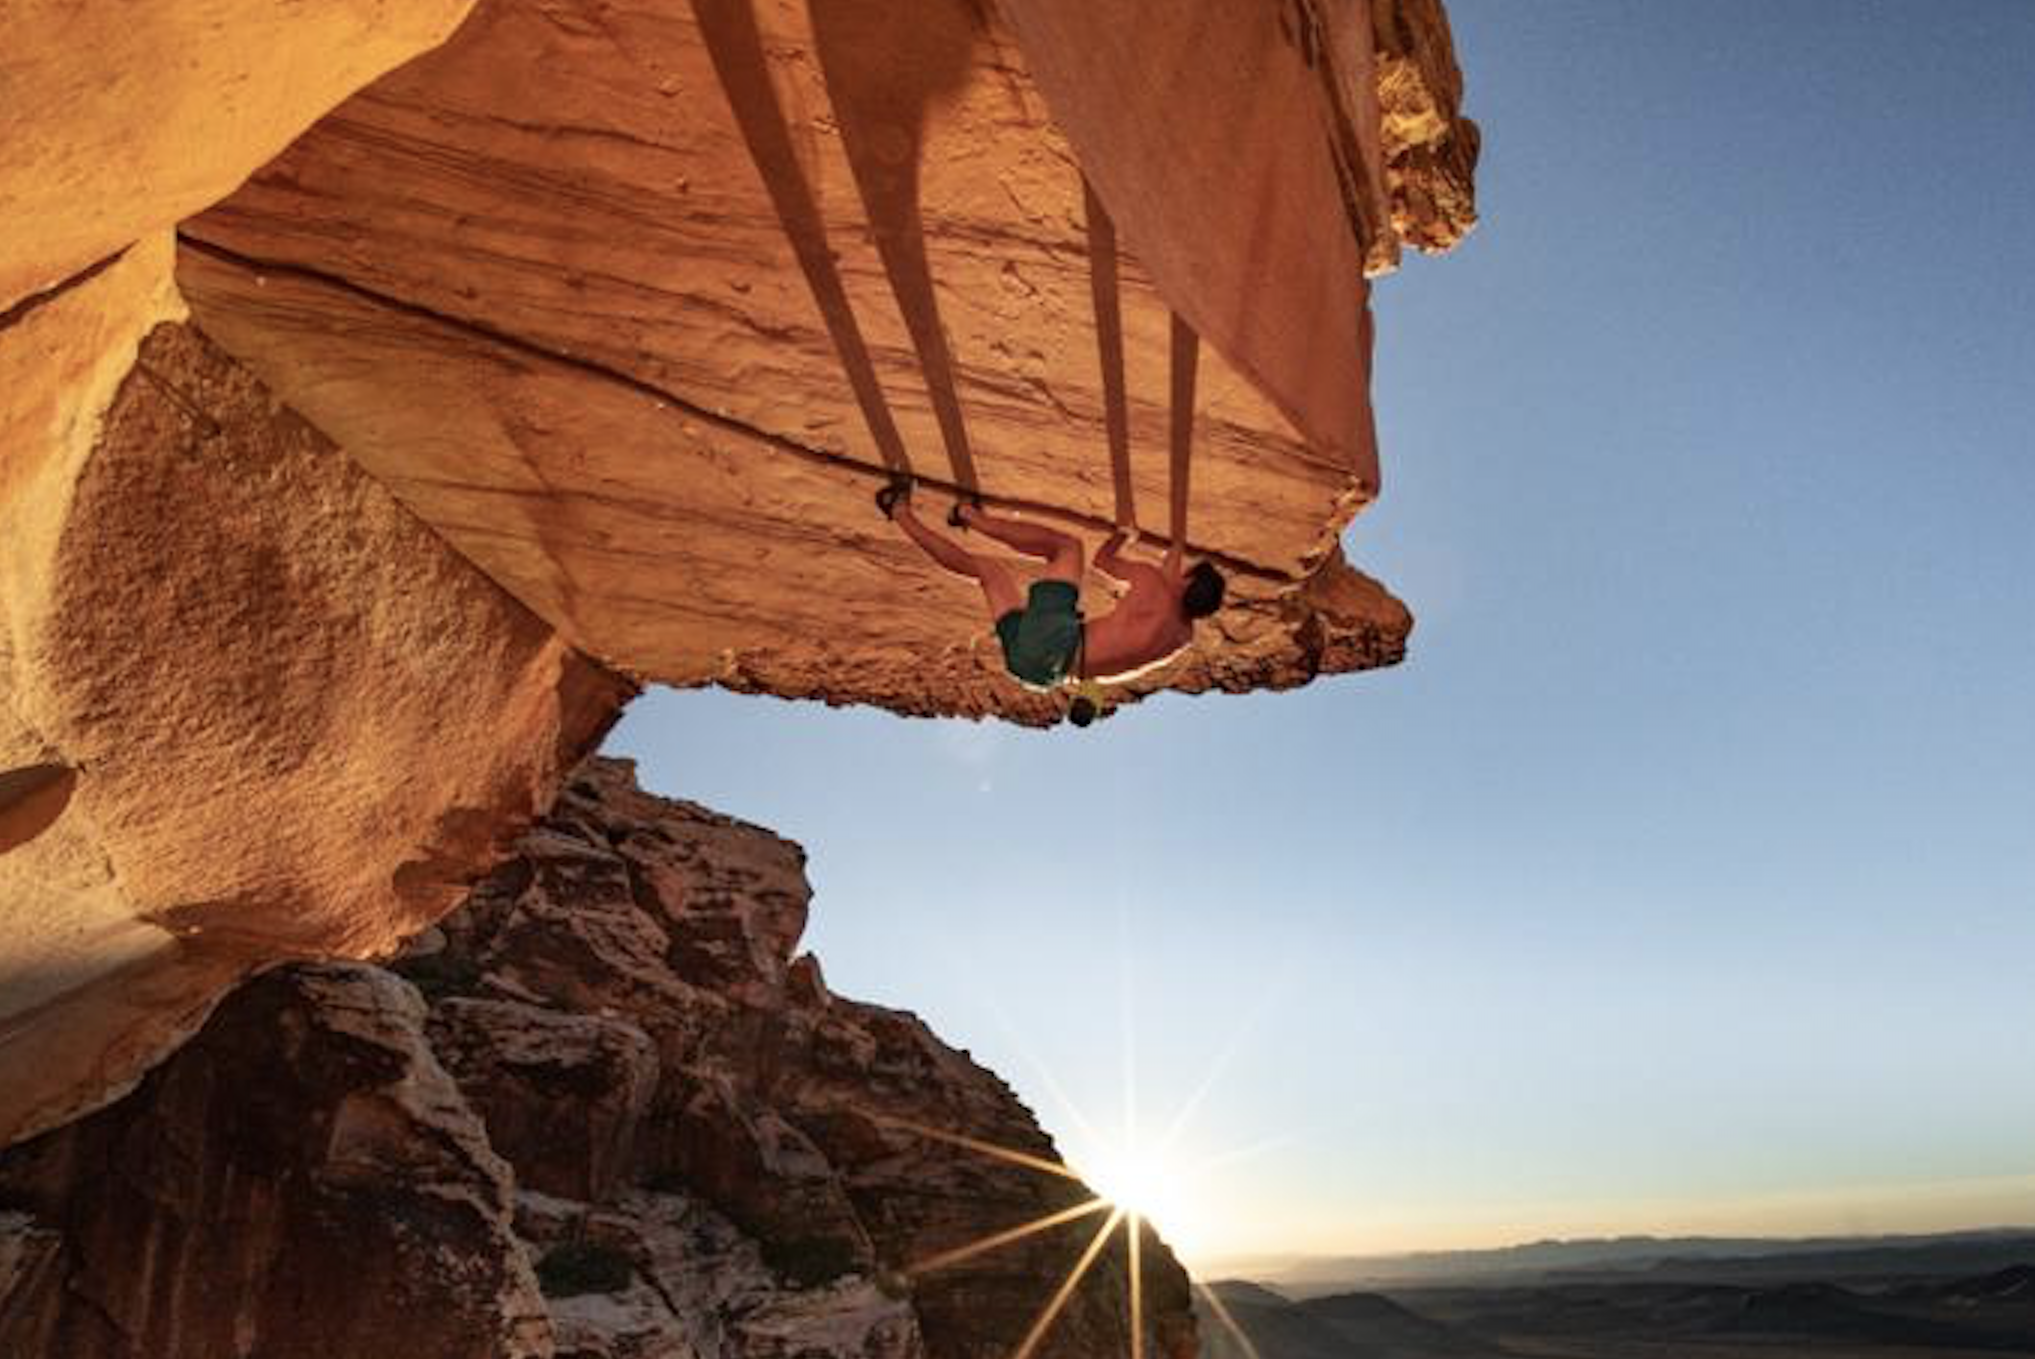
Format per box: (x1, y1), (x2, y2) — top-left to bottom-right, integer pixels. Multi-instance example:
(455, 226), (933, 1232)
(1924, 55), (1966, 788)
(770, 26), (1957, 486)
(0, 236), (631, 1143)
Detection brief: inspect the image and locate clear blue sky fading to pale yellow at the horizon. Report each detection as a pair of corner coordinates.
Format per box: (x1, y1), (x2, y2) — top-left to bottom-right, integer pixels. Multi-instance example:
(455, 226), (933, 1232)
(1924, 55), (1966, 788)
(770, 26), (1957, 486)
(611, 0), (2035, 1261)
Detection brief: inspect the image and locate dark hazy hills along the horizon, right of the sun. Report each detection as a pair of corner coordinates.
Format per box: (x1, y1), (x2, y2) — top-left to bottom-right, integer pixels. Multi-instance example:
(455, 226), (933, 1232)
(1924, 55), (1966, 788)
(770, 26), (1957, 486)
(1199, 1231), (2035, 1359)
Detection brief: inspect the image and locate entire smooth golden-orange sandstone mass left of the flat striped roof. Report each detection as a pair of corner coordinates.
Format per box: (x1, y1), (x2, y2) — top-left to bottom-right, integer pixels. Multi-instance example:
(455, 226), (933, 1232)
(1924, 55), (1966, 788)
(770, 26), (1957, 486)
(0, 0), (633, 1143)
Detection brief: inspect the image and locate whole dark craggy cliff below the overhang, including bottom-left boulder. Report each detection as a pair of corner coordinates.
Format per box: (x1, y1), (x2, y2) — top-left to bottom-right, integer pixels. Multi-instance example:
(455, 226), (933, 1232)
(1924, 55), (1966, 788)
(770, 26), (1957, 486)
(0, 761), (1195, 1359)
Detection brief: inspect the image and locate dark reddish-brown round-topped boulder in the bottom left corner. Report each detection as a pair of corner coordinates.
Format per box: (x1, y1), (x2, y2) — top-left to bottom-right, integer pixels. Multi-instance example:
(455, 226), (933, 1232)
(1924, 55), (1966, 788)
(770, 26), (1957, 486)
(0, 964), (551, 1359)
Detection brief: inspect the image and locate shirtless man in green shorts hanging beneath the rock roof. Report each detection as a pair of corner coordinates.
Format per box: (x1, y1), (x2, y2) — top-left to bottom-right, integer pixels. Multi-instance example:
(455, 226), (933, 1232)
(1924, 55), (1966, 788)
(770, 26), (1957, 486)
(877, 480), (1223, 726)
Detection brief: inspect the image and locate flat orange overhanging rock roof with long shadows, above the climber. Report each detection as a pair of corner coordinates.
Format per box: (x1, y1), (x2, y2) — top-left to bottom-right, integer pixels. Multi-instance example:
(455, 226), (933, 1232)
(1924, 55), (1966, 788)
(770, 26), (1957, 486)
(179, 0), (1475, 722)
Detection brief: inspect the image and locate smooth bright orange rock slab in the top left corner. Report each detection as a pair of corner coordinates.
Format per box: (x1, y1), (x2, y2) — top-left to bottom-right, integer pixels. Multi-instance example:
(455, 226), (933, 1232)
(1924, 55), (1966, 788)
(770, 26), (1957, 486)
(0, 0), (472, 309)
